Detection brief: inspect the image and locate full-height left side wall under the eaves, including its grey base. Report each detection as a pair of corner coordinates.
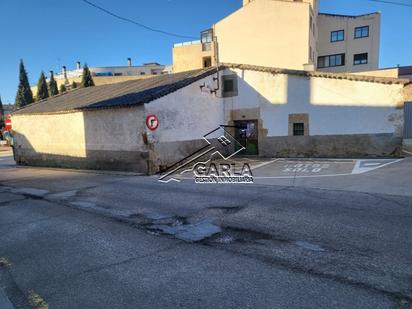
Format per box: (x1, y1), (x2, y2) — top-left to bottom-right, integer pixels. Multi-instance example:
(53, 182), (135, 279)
(12, 106), (148, 172)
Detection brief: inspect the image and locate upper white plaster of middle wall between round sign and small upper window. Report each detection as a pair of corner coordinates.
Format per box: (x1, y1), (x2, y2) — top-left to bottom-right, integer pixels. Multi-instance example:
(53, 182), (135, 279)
(145, 75), (224, 143)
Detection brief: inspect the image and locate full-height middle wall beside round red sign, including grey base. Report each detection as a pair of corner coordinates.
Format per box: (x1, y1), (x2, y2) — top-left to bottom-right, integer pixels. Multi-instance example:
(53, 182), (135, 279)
(145, 75), (224, 165)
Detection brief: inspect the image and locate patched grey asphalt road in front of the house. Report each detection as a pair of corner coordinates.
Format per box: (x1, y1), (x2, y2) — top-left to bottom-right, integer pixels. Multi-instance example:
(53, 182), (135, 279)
(0, 149), (412, 309)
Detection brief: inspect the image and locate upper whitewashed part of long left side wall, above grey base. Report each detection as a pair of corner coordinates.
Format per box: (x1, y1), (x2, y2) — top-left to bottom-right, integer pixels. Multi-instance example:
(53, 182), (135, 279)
(12, 106), (145, 158)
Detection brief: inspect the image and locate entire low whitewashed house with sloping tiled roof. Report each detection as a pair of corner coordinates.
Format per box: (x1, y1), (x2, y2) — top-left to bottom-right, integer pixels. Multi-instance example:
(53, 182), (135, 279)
(12, 64), (410, 173)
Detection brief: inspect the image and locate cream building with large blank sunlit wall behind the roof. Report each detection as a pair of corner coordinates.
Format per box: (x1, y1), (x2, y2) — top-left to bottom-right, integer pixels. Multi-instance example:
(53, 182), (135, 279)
(173, 0), (318, 72)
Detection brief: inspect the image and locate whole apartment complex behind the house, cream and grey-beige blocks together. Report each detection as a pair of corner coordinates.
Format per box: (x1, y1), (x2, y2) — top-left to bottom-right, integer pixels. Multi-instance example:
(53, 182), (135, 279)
(173, 0), (380, 72)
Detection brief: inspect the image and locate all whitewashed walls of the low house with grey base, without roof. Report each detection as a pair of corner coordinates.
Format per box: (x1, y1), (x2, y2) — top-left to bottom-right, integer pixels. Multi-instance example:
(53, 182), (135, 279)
(12, 69), (404, 173)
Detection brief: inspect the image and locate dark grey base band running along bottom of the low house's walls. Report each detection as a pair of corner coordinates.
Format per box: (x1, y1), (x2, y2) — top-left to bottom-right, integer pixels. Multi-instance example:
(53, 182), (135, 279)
(15, 134), (402, 174)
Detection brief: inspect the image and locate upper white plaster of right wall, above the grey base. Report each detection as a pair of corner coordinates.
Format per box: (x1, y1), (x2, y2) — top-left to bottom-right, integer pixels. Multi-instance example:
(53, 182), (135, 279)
(224, 70), (403, 136)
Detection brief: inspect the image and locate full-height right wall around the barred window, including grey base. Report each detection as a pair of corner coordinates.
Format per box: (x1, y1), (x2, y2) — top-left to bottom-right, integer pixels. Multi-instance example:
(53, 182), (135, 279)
(224, 70), (404, 156)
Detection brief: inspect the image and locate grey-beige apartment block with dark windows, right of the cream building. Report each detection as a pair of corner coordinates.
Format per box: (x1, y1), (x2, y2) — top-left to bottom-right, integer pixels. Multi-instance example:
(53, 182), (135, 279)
(317, 13), (381, 72)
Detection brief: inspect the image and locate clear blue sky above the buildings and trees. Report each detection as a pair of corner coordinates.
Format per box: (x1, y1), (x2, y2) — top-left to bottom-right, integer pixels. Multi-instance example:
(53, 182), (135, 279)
(0, 0), (412, 103)
